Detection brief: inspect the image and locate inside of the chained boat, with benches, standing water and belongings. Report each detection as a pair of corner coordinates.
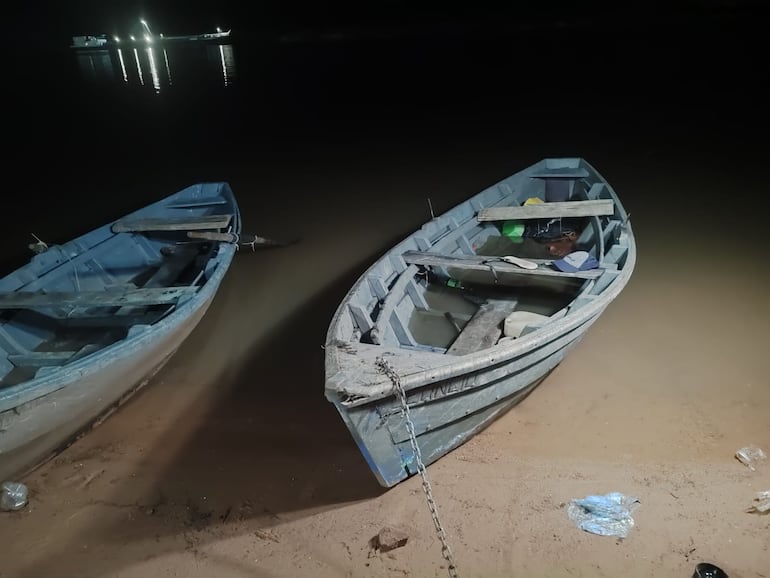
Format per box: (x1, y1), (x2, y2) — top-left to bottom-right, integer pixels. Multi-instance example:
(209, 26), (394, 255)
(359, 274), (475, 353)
(337, 159), (628, 355)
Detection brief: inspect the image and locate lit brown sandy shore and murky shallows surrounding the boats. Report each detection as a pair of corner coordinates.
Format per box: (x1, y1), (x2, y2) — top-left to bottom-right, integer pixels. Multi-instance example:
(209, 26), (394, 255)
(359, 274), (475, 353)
(0, 130), (770, 578)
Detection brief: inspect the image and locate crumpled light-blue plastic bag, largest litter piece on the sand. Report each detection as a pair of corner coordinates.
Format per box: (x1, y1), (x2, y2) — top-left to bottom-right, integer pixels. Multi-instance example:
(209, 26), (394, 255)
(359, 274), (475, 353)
(567, 492), (639, 538)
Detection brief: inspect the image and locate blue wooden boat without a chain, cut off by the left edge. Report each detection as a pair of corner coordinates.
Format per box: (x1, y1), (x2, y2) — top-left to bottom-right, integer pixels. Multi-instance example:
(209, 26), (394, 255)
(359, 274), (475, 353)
(0, 182), (241, 479)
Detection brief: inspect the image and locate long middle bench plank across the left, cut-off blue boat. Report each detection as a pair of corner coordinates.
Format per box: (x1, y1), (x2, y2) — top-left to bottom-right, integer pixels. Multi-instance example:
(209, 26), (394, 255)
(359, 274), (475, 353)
(0, 287), (195, 309)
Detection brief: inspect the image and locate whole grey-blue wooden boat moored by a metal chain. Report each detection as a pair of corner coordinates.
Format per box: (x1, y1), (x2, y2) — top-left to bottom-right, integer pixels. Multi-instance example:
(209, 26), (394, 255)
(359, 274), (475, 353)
(325, 158), (636, 487)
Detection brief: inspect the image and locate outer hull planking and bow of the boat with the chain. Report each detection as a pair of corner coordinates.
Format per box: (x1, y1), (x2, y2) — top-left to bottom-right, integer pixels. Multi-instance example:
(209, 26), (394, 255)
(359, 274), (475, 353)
(330, 304), (601, 487)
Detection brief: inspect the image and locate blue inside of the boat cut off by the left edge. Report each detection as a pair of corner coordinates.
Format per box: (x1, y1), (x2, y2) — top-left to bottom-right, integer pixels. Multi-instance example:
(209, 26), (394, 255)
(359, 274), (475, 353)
(0, 198), (233, 388)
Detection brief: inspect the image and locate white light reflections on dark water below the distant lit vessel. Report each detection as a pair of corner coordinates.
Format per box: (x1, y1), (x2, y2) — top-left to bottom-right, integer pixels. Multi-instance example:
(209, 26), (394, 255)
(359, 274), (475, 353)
(75, 44), (236, 93)
